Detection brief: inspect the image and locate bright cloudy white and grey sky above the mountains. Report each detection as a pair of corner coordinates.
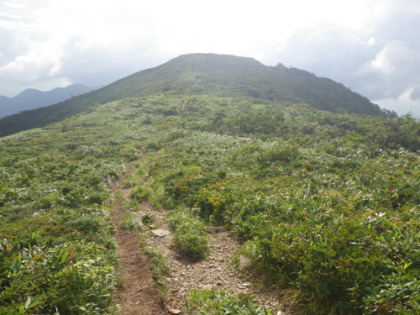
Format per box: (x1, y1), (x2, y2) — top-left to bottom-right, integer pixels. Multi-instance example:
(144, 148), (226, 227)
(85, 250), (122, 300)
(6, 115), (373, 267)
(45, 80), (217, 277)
(0, 0), (420, 117)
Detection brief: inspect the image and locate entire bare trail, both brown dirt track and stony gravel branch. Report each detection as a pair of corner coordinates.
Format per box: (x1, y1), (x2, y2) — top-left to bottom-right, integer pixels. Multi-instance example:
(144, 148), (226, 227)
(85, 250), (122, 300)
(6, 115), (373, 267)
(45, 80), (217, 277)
(113, 156), (286, 315)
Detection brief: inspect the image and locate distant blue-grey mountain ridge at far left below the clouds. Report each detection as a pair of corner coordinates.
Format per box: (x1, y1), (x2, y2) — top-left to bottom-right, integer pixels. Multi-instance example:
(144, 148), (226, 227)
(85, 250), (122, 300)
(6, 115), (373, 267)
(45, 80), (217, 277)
(0, 84), (91, 117)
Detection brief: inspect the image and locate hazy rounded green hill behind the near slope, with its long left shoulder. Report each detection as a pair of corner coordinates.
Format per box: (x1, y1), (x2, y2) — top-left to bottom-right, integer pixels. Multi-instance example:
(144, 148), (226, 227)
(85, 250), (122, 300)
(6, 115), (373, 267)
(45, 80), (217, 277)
(0, 54), (389, 136)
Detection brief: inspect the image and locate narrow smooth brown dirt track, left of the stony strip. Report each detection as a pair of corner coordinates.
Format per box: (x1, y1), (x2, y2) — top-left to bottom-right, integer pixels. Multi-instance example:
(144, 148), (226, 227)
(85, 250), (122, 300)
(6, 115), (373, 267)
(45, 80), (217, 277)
(112, 164), (167, 315)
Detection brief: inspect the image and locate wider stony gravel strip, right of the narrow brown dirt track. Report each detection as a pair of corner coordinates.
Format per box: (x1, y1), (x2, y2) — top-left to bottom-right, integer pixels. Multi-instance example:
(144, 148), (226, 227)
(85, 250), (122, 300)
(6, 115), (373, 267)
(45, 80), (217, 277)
(137, 202), (285, 314)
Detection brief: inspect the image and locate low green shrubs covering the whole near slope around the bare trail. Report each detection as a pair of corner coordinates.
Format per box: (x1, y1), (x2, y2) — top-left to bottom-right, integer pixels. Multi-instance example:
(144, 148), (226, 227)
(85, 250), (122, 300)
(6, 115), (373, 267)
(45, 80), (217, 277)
(0, 78), (420, 314)
